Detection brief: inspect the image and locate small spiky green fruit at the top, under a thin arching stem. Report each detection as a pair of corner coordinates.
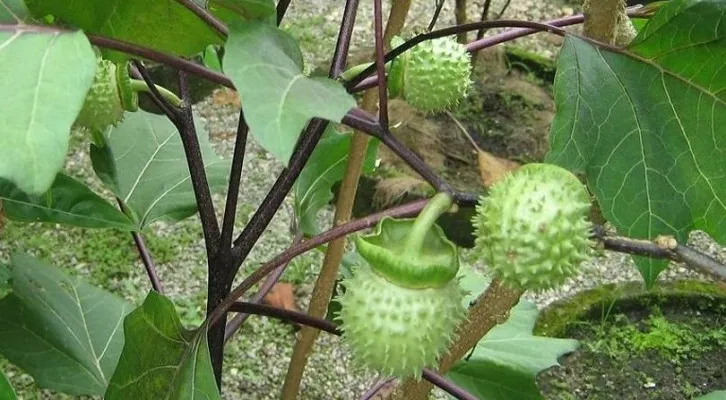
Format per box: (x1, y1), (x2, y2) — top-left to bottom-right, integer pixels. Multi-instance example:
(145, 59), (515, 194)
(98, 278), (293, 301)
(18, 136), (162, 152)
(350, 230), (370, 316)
(389, 37), (472, 112)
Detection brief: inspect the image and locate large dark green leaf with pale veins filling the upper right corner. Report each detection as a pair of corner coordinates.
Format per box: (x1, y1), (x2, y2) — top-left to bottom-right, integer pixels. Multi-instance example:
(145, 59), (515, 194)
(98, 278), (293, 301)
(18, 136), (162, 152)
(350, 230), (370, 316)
(547, 0), (726, 285)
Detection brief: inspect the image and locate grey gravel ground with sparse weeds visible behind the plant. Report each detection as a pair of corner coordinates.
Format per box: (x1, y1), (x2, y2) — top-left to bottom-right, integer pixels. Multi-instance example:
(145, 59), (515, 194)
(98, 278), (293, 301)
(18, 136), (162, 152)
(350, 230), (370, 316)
(0, 0), (726, 400)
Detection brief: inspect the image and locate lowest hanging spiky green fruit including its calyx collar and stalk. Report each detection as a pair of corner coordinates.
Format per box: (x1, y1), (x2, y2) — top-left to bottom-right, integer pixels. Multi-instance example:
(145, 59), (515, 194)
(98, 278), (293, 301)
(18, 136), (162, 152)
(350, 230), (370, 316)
(338, 194), (466, 379)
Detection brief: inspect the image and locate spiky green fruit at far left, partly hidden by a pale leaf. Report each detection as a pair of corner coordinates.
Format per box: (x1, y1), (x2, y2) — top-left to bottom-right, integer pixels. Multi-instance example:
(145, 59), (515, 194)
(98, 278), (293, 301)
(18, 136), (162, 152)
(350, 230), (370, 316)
(76, 56), (124, 132)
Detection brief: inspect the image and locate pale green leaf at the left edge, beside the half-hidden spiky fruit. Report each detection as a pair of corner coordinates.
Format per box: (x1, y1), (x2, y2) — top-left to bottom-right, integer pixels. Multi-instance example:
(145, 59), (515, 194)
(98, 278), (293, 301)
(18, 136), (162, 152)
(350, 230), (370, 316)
(0, 26), (96, 195)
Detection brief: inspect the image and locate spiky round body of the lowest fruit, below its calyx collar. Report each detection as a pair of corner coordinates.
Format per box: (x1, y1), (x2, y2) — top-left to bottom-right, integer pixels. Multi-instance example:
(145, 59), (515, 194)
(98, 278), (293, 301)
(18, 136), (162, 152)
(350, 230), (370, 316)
(338, 266), (465, 379)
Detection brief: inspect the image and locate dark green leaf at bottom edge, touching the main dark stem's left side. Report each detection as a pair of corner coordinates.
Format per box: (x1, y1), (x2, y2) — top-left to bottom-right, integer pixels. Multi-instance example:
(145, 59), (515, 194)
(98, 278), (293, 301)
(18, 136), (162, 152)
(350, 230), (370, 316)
(105, 291), (221, 400)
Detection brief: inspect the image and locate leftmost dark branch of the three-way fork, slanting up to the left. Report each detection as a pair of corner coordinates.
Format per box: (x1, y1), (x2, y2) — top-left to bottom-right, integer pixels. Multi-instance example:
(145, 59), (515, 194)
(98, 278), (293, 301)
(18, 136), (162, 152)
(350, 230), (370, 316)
(177, 71), (219, 259)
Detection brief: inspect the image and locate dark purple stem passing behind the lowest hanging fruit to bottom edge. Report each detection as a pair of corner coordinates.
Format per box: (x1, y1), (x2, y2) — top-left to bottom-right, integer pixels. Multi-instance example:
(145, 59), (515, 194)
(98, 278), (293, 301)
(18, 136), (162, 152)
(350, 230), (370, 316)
(229, 301), (477, 400)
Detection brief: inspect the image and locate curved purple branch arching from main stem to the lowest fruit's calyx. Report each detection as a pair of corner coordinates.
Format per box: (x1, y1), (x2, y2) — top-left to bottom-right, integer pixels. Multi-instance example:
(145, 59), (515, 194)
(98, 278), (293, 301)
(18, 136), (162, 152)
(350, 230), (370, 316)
(208, 199), (428, 326)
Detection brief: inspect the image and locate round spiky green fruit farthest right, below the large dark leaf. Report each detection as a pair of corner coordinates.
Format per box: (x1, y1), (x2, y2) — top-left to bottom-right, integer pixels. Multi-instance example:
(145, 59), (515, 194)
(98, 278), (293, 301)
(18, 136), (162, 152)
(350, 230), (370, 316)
(473, 163), (593, 291)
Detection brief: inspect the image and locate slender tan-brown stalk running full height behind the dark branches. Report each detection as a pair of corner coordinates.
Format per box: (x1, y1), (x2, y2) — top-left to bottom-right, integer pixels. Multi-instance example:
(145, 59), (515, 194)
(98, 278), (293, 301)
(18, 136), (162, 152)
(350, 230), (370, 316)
(282, 0), (411, 400)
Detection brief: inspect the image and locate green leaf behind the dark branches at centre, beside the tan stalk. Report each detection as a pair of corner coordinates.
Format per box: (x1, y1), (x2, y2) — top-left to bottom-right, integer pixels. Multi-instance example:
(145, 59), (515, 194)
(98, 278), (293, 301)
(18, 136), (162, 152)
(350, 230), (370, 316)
(293, 128), (378, 236)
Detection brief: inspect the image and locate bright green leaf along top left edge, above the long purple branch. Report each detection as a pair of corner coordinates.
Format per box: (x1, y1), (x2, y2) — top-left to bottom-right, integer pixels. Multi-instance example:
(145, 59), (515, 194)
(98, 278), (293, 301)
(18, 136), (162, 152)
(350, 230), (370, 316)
(25, 0), (222, 62)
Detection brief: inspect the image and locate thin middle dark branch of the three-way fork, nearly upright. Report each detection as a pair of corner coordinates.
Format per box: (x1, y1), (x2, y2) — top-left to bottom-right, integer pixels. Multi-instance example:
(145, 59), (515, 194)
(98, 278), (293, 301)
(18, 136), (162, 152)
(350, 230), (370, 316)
(219, 110), (249, 252)
